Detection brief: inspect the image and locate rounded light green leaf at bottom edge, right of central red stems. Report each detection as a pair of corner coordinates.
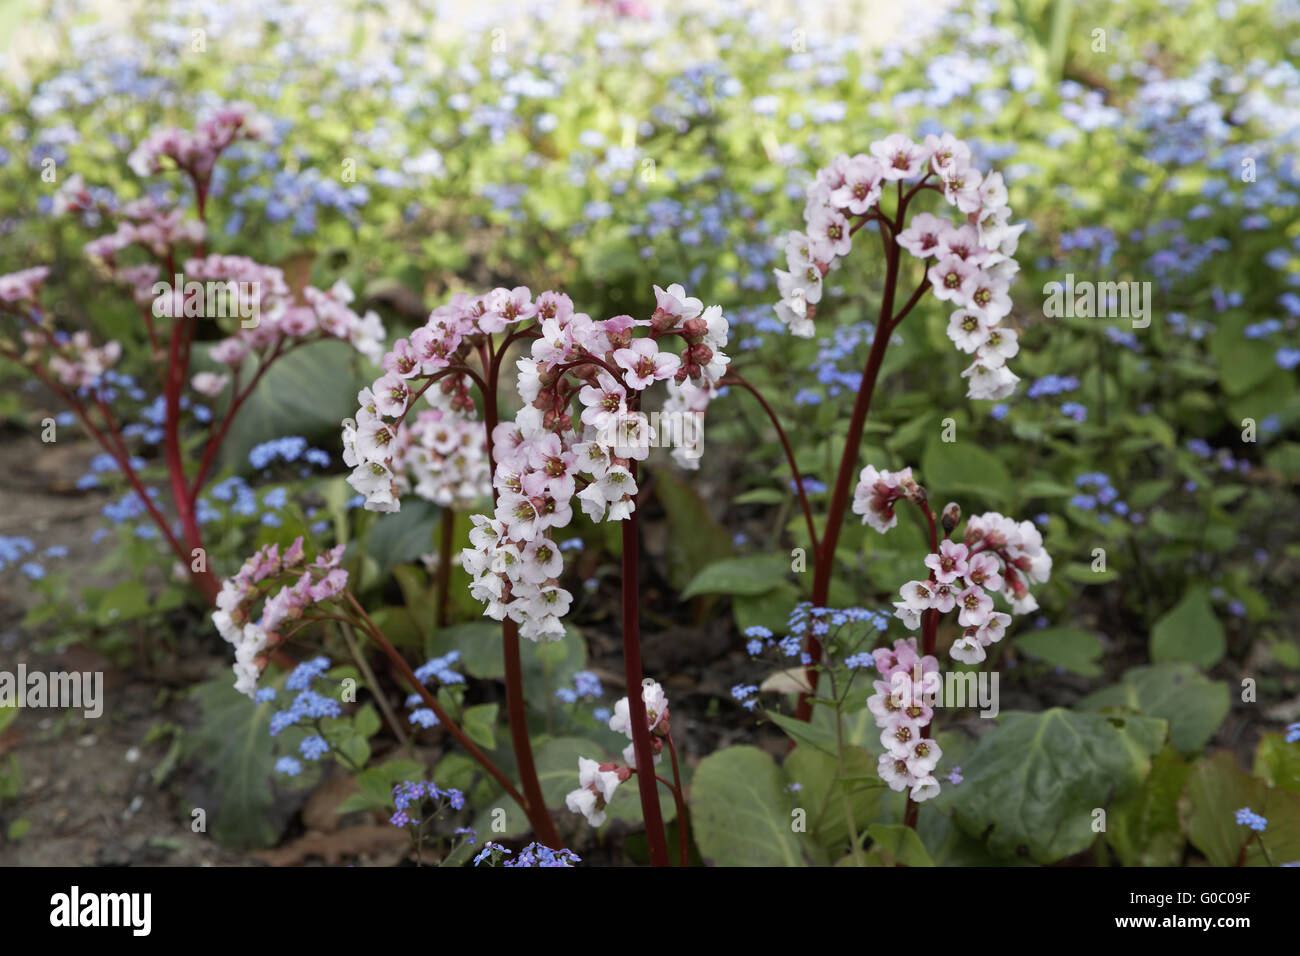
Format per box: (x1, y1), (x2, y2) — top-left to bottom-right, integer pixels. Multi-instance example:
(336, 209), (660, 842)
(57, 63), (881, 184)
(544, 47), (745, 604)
(690, 747), (822, 866)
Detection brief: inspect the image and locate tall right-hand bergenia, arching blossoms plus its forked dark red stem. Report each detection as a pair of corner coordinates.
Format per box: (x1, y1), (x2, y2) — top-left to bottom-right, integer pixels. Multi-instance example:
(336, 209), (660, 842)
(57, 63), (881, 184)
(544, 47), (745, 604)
(759, 133), (1024, 719)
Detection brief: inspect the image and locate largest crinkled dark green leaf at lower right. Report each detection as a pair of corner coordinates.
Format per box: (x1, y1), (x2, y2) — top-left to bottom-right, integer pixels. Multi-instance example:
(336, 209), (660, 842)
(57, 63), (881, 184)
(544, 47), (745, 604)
(952, 708), (1165, 864)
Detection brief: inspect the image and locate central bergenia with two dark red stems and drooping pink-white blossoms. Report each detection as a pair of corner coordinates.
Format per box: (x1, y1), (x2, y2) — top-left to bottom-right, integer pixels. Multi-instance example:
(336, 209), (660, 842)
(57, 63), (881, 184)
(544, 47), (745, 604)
(317, 285), (729, 862)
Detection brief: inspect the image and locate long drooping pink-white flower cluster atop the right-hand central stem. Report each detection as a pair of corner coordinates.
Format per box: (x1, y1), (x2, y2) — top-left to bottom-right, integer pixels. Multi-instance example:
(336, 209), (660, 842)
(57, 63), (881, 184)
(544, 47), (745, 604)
(457, 285), (729, 640)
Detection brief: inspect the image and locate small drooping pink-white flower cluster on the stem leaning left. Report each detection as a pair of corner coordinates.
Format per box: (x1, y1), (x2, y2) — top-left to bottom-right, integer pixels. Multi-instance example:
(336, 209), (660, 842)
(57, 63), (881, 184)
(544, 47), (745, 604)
(212, 537), (347, 697)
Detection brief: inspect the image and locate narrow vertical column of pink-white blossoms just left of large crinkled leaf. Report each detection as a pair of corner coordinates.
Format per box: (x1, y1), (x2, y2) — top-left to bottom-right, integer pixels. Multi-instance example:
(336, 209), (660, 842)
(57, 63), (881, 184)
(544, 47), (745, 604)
(867, 637), (944, 804)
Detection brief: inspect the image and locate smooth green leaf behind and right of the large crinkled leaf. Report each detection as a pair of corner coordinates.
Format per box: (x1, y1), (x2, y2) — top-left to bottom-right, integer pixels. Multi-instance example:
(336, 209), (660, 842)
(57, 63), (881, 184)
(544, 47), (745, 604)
(1078, 663), (1230, 753)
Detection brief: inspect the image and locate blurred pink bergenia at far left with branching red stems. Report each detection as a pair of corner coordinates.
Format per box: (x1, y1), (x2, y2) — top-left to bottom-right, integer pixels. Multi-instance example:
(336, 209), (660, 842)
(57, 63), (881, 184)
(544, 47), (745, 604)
(0, 103), (385, 601)
